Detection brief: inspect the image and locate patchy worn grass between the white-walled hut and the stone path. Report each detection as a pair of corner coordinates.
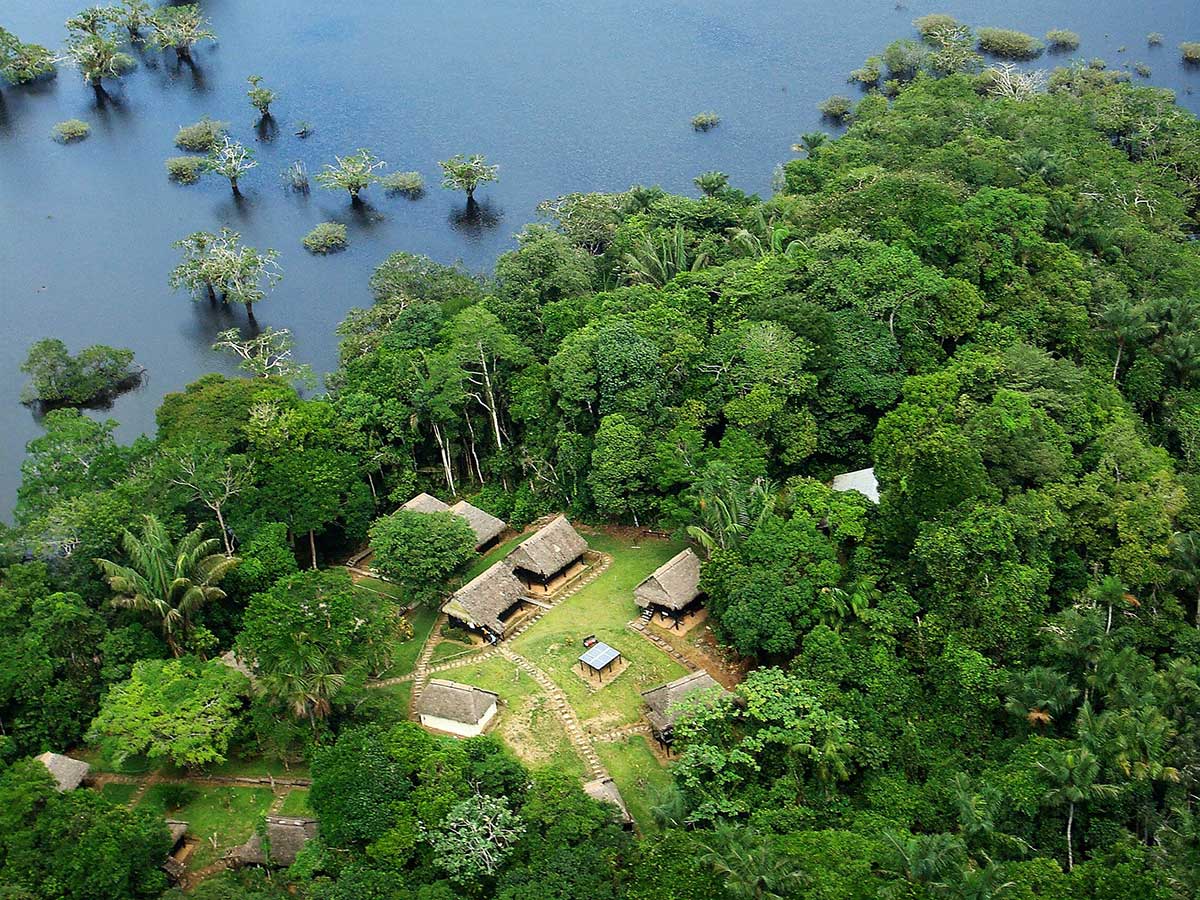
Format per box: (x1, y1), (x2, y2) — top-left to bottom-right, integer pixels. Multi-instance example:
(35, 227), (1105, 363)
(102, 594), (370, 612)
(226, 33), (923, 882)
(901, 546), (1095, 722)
(451, 656), (586, 779)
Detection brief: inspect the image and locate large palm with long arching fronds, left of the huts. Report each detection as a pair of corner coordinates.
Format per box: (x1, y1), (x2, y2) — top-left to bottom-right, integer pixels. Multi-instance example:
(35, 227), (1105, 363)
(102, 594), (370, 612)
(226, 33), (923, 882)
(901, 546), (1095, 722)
(94, 516), (241, 656)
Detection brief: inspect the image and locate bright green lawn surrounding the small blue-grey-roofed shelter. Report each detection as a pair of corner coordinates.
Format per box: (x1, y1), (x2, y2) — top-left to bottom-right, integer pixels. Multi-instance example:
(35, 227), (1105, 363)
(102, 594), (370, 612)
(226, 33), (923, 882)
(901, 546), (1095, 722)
(512, 534), (686, 731)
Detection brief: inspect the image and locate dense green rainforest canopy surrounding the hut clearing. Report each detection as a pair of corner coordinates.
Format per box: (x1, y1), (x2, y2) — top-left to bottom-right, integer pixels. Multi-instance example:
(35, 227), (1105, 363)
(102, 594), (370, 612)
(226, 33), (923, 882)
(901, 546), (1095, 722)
(0, 24), (1200, 900)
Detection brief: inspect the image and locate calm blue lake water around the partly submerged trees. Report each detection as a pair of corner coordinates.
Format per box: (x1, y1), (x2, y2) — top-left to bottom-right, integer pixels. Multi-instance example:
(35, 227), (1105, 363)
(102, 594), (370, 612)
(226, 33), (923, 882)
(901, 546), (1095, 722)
(0, 0), (1200, 515)
